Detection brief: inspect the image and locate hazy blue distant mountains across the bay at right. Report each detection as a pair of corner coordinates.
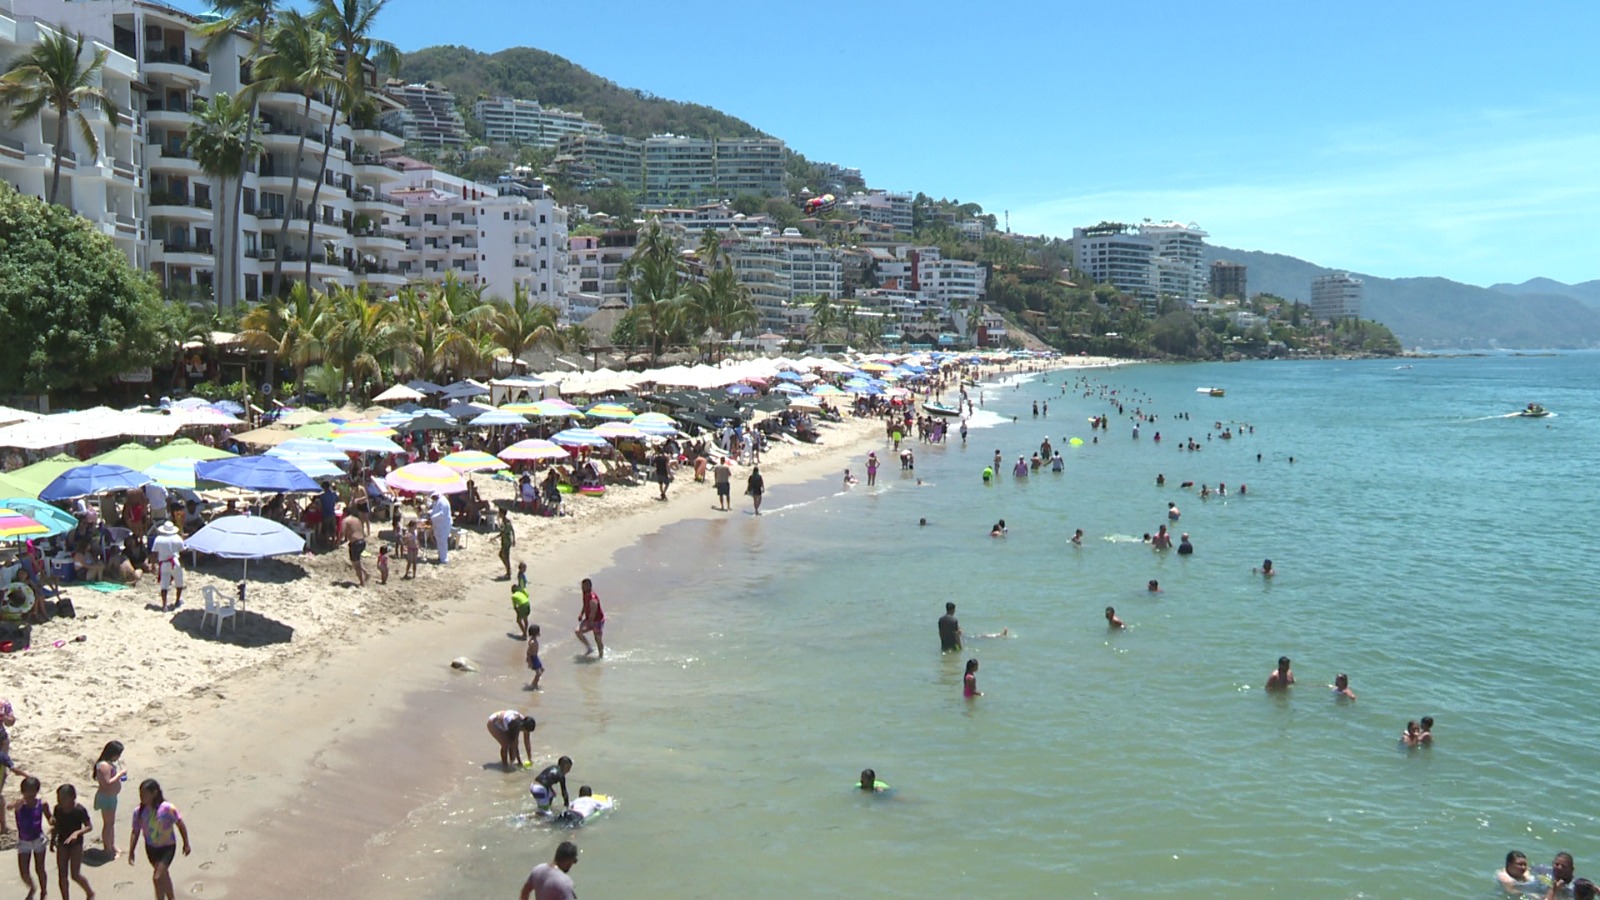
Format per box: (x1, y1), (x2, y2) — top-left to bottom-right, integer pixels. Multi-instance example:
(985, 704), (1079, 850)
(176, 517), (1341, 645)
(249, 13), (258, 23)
(1206, 247), (1600, 349)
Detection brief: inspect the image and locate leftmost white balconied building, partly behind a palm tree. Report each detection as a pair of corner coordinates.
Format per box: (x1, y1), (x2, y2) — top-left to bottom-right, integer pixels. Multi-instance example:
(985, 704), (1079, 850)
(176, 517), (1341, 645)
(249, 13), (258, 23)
(0, 0), (149, 267)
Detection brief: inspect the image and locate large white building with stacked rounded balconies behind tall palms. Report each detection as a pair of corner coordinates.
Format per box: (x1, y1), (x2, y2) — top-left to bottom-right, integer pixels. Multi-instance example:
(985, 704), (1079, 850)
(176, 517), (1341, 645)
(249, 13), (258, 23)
(0, 0), (403, 301)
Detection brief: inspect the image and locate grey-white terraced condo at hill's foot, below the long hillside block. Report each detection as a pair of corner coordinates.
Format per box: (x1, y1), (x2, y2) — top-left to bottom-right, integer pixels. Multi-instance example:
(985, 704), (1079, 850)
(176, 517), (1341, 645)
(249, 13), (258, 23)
(725, 229), (843, 333)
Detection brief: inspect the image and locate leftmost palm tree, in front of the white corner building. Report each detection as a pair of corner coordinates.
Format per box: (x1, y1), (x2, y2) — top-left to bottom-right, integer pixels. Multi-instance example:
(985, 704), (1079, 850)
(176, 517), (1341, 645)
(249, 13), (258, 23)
(0, 32), (118, 203)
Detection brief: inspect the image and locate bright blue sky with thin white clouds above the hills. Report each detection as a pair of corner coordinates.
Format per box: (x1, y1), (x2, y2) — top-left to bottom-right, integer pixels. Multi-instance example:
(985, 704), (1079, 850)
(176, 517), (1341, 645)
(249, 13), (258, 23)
(179, 0), (1600, 285)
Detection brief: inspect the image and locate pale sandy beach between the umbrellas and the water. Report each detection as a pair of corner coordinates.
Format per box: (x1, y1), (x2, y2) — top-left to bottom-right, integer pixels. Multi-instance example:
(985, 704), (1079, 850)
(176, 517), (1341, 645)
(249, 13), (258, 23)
(3, 359), (1112, 897)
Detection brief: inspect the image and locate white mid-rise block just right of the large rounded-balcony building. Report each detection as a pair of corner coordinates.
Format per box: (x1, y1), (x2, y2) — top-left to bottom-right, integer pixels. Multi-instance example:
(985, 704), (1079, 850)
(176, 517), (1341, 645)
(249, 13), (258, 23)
(389, 157), (566, 317)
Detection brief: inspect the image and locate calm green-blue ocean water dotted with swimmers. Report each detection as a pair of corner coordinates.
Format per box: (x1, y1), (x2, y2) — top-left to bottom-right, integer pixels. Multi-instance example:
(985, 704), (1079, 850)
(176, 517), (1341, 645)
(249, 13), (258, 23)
(354, 354), (1600, 900)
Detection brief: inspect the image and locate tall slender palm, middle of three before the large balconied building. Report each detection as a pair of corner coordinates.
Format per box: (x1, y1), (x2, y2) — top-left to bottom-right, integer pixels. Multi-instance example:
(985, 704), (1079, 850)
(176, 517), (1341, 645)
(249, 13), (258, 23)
(250, 10), (339, 296)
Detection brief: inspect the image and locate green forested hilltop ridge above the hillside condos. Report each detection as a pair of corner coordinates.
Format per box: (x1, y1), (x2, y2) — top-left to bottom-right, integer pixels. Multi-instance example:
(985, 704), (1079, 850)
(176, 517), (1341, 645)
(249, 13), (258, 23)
(400, 45), (766, 138)
